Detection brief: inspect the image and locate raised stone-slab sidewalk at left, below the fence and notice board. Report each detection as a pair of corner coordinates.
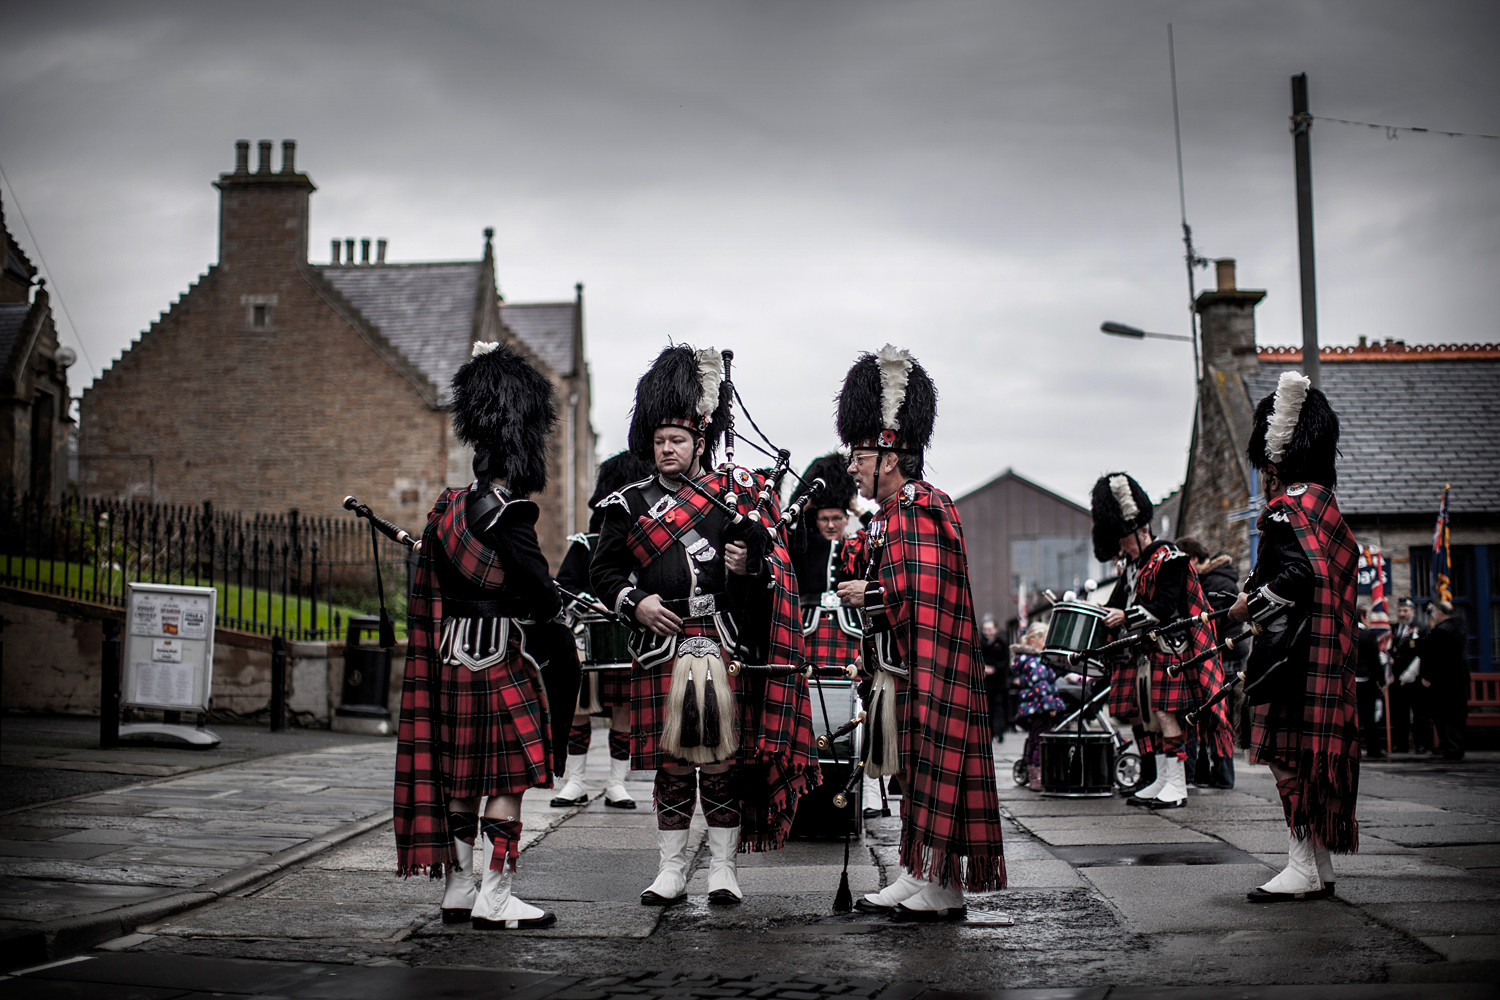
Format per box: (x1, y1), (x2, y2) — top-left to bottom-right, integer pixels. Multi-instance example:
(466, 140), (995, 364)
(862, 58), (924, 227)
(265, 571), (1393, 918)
(0, 720), (395, 967)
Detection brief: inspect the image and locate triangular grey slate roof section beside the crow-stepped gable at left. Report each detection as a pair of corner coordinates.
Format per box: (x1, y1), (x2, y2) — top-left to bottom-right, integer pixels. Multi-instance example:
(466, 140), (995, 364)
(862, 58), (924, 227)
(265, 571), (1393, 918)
(318, 261), (482, 400)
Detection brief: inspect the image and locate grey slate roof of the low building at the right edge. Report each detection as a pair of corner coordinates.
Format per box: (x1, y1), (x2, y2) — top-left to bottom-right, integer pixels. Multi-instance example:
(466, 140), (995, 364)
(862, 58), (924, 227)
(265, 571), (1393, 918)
(1245, 358), (1500, 514)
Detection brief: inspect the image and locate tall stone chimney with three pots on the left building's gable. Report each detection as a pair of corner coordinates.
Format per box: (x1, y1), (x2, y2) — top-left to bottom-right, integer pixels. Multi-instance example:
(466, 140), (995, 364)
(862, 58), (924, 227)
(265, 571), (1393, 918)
(213, 139), (317, 270)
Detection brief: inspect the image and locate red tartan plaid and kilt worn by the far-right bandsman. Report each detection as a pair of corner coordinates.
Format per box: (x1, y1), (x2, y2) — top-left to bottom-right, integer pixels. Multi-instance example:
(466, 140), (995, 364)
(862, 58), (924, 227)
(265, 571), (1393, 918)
(1251, 483), (1359, 855)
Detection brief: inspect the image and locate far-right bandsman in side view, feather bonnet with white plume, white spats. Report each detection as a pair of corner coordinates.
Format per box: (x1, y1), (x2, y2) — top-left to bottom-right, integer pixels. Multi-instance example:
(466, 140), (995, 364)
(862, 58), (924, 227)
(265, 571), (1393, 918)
(1230, 372), (1359, 903)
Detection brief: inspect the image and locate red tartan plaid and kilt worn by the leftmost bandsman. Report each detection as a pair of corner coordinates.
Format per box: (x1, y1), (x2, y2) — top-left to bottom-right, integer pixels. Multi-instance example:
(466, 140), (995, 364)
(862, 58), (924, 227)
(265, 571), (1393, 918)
(393, 489), (546, 879)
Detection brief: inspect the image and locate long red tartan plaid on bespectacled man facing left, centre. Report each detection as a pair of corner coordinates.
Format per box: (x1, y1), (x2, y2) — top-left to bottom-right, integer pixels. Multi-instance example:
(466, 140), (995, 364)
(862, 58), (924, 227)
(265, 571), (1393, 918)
(872, 481), (1005, 892)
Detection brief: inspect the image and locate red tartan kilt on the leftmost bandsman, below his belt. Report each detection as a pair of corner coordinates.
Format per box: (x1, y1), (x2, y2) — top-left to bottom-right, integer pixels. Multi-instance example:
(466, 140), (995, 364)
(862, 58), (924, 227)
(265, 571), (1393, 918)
(437, 650), (552, 799)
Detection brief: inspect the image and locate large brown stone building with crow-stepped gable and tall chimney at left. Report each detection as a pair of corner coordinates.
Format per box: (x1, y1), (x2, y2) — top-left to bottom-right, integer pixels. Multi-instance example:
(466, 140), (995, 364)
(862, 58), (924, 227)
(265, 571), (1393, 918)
(80, 141), (594, 559)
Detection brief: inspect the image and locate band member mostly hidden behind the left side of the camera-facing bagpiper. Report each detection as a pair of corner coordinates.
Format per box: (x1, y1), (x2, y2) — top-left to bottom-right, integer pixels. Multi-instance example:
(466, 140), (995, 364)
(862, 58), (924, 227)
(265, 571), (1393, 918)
(552, 451), (654, 810)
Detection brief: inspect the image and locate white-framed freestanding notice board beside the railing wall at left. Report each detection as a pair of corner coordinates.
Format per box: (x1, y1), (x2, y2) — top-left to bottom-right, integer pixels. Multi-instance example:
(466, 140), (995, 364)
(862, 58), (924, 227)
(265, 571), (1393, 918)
(120, 583), (219, 712)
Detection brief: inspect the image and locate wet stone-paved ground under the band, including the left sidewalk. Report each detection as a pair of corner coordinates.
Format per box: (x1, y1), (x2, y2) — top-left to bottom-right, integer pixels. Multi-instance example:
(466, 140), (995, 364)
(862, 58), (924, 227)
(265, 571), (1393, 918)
(3, 722), (1500, 1000)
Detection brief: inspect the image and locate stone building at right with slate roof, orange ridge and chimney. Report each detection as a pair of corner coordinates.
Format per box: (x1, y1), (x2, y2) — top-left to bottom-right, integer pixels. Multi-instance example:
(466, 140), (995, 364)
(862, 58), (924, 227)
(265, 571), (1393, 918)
(1172, 259), (1500, 672)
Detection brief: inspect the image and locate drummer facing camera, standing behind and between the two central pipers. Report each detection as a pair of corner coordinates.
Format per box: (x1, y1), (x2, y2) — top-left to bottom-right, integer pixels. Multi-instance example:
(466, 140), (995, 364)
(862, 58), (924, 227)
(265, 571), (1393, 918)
(788, 453), (867, 680)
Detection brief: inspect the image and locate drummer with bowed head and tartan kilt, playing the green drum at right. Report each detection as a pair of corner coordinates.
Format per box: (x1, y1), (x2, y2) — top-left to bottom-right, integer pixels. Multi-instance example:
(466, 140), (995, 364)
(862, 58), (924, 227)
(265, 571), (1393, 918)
(1094, 472), (1235, 810)
